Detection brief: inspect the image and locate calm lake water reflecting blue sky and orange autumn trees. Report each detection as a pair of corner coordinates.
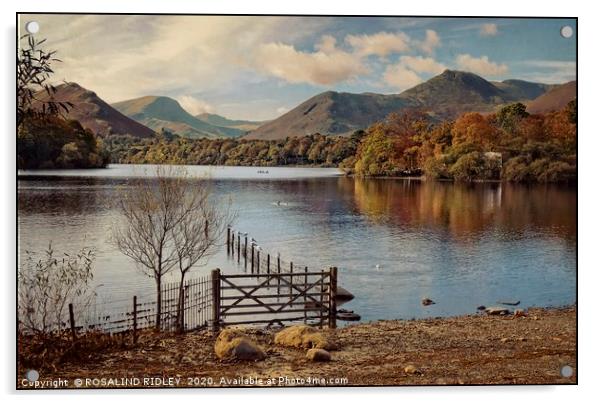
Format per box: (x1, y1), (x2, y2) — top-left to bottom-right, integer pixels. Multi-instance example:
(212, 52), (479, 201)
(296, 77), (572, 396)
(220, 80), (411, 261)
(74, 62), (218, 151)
(18, 165), (576, 320)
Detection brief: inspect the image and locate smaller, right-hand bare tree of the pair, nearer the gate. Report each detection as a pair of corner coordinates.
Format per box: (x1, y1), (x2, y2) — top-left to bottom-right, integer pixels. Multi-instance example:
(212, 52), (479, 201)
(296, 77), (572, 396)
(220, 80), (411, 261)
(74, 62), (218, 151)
(172, 185), (234, 332)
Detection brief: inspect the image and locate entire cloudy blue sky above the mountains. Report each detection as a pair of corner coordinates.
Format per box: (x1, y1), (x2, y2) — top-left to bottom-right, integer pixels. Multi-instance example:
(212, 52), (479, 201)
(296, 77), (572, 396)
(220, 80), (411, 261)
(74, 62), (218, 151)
(19, 14), (577, 120)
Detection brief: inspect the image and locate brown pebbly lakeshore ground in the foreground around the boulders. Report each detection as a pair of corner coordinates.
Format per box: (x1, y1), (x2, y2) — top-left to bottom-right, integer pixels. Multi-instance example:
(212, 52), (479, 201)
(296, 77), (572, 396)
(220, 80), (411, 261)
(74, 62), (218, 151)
(18, 307), (577, 387)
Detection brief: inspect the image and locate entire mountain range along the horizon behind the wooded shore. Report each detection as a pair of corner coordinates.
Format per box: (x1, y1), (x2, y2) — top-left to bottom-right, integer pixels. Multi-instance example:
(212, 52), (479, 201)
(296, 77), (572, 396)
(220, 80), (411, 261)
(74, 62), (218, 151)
(37, 70), (576, 139)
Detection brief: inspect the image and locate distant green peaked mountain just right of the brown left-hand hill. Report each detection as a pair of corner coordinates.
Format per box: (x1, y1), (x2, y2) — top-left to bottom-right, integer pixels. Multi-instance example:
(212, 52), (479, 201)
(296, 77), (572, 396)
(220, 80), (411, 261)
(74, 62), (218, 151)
(112, 96), (245, 138)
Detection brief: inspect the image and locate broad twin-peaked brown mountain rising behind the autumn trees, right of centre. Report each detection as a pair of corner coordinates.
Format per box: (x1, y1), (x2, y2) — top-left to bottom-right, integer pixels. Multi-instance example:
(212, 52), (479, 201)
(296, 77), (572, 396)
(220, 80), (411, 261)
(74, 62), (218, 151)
(245, 70), (549, 139)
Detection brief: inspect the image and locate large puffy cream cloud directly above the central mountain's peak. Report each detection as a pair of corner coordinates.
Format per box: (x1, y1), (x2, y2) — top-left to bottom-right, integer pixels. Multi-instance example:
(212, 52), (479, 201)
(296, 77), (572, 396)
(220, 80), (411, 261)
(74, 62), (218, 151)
(252, 38), (369, 85)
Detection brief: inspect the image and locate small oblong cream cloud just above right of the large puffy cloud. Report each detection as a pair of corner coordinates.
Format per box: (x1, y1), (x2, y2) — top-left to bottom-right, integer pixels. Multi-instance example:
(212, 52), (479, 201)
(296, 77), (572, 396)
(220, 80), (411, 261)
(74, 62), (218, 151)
(345, 32), (410, 57)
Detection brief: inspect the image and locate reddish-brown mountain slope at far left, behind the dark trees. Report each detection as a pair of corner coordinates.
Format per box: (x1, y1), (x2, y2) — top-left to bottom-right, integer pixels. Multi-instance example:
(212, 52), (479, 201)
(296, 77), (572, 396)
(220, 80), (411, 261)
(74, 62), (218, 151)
(36, 83), (154, 137)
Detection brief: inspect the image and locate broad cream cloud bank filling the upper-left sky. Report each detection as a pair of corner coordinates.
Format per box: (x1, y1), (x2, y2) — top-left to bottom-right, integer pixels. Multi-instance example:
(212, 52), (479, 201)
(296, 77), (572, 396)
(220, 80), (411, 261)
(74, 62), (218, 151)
(24, 15), (330, 102)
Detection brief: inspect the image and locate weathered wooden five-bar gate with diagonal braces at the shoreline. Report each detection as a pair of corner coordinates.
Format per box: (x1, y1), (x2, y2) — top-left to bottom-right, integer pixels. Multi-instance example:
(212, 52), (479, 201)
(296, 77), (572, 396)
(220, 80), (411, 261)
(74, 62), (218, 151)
(212, 267), (337, 330)
